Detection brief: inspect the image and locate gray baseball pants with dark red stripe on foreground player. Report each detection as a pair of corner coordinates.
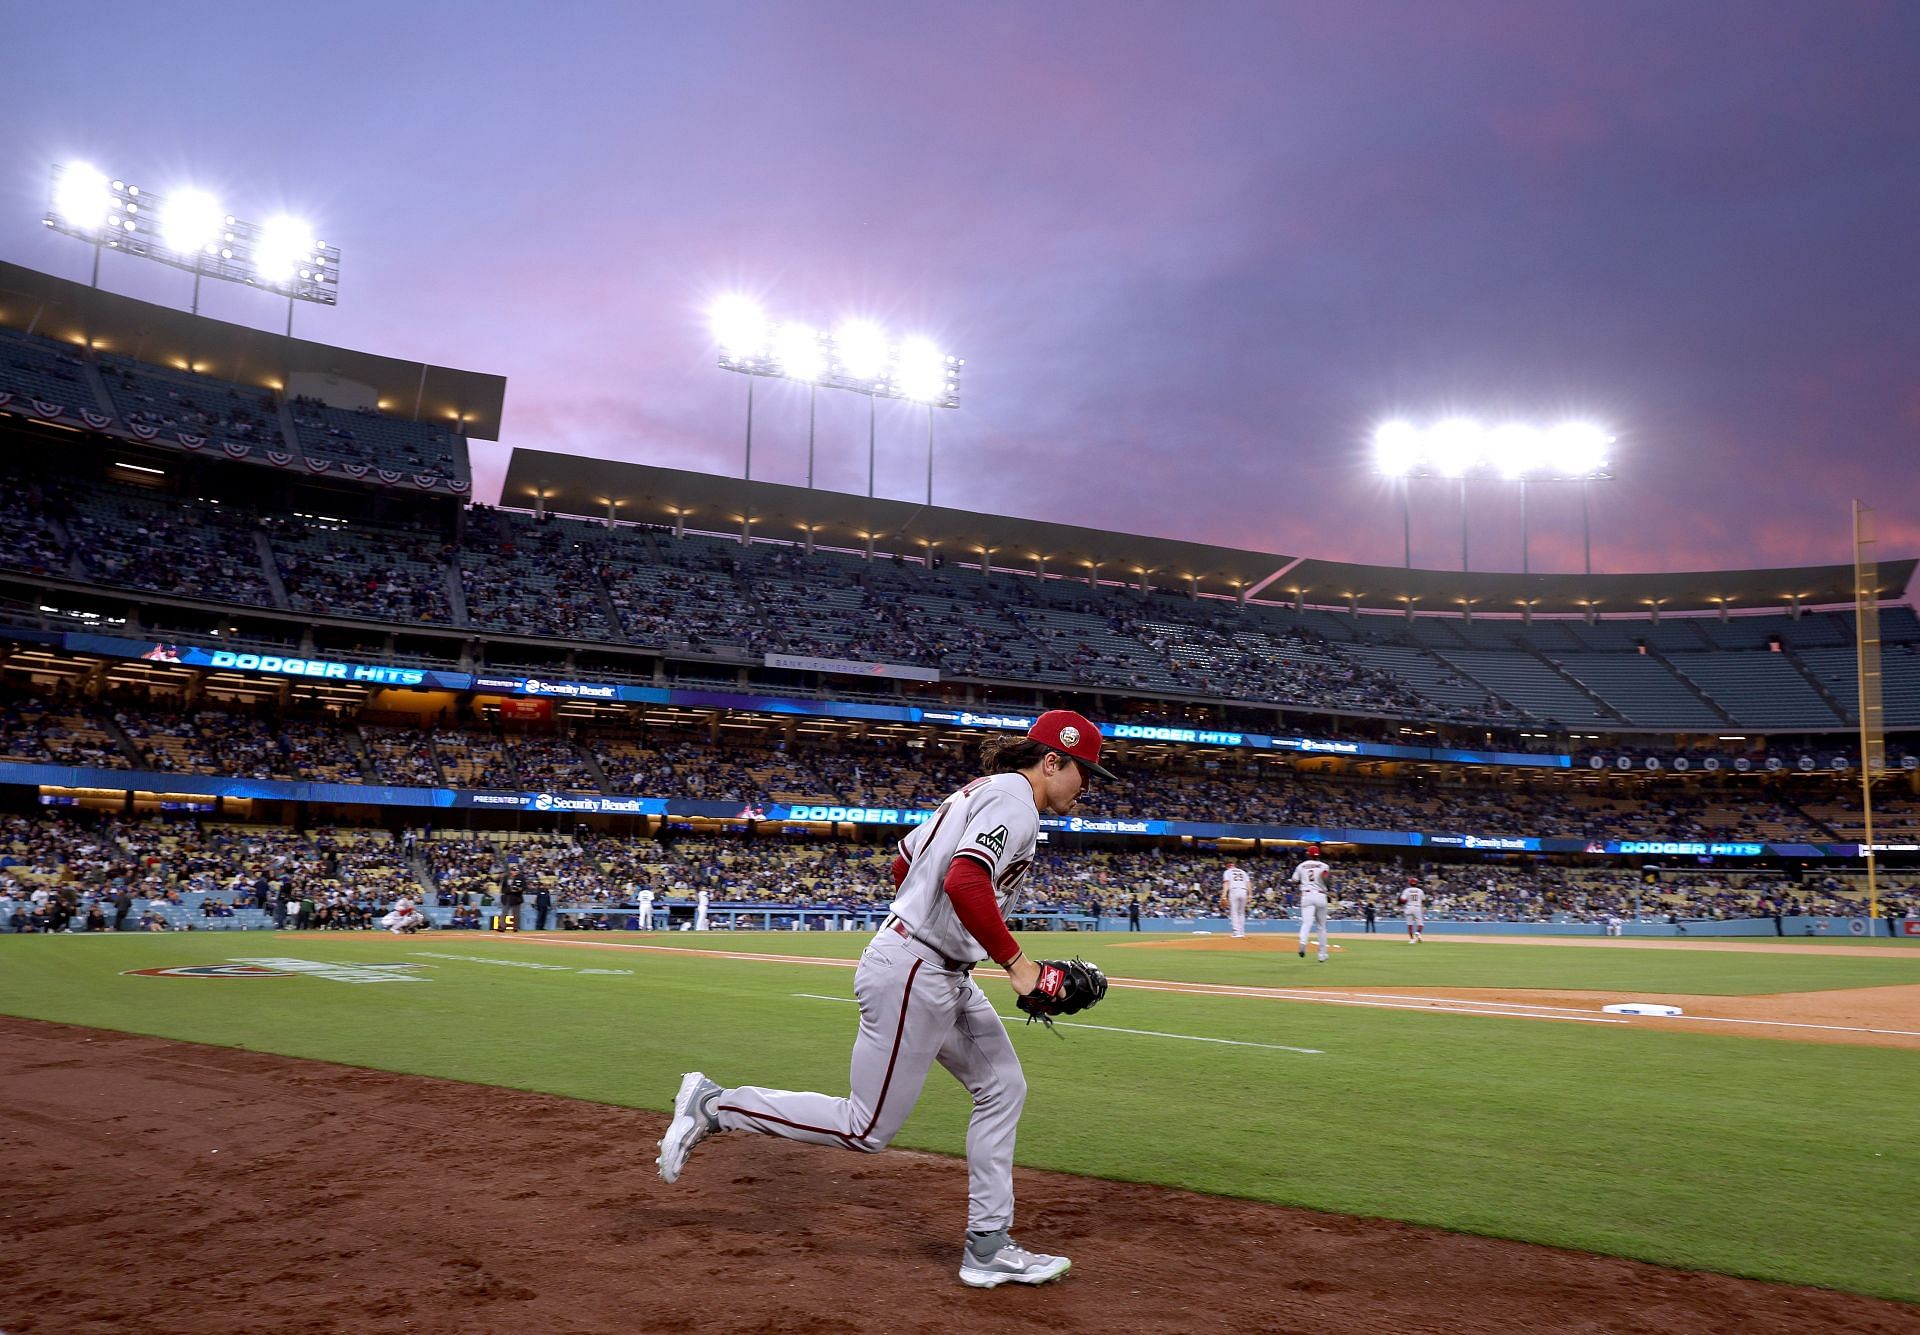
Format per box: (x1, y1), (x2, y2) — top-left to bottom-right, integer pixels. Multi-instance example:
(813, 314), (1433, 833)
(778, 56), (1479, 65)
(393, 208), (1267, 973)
(716, 928), (1027, 1233)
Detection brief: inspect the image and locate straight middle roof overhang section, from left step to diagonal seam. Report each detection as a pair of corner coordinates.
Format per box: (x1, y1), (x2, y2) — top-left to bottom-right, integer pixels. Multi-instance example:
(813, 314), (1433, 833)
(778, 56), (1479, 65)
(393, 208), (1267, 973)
(499, 449), (1294, 595)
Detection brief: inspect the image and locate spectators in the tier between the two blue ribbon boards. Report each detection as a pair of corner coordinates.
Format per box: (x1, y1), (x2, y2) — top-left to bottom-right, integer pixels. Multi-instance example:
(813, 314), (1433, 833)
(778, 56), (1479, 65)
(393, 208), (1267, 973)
(0, 672), (1881, 843)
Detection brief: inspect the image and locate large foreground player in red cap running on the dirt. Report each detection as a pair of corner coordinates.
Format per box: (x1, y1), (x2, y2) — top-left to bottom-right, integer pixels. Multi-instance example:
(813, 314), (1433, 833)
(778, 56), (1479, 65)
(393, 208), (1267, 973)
(657, 709), (1112, 1289)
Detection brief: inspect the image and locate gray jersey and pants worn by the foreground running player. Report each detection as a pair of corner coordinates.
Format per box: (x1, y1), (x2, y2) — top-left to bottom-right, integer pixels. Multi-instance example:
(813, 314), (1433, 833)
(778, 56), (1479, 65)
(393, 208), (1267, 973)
(714, 774), (1041, 1233)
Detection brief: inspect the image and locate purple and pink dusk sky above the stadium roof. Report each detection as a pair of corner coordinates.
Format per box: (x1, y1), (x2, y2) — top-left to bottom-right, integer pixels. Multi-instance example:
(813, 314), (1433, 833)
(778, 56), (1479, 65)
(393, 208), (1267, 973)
(0, 0), (1920, 570)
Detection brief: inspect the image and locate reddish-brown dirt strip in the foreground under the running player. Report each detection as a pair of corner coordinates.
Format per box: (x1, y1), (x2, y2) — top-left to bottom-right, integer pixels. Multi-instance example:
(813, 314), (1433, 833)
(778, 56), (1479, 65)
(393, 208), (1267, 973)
(0, 1018), (1920, 1335)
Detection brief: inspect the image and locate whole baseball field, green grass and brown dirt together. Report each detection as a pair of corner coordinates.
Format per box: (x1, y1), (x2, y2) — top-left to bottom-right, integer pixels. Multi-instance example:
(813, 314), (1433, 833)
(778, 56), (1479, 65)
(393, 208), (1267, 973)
(0, 934), (1920, 1331)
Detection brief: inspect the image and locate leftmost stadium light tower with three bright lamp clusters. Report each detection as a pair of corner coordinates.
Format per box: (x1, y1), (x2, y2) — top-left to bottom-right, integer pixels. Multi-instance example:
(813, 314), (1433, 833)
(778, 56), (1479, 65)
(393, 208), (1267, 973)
(44, 161), (340, 338)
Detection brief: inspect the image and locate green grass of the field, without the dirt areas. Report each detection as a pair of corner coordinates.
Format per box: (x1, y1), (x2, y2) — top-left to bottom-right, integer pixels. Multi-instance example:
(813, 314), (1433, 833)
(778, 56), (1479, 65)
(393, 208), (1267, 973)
(0, 934), (1920, 1300)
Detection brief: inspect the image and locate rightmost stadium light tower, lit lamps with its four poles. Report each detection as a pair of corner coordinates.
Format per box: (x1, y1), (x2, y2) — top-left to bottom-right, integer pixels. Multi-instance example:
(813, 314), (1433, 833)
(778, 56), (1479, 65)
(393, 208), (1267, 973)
(1373, 417), (1615, 574)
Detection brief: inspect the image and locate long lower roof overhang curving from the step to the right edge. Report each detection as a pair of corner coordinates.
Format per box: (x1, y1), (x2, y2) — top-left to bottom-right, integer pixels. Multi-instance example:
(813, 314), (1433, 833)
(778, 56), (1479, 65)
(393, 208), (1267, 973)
(499, 448), (1914, 617)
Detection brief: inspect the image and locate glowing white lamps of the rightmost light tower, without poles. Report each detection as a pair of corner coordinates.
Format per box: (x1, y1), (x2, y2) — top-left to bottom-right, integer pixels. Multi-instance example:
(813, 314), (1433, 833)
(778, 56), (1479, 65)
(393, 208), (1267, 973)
(1373, 417), (1613, 482)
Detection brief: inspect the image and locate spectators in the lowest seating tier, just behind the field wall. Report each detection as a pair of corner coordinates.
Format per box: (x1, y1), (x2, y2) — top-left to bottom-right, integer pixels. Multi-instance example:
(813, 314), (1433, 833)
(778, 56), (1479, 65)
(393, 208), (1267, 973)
(0, 814), (1920, 932)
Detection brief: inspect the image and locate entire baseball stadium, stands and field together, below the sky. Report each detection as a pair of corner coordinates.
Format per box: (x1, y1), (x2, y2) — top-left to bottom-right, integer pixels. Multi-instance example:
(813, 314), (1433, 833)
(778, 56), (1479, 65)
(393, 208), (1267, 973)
(0, 245), (1920, 1331)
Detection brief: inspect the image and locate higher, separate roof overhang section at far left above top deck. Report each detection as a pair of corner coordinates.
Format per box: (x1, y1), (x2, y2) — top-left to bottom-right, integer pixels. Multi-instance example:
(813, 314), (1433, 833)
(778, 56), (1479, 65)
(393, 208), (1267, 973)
(0, 261), (507, 440)
